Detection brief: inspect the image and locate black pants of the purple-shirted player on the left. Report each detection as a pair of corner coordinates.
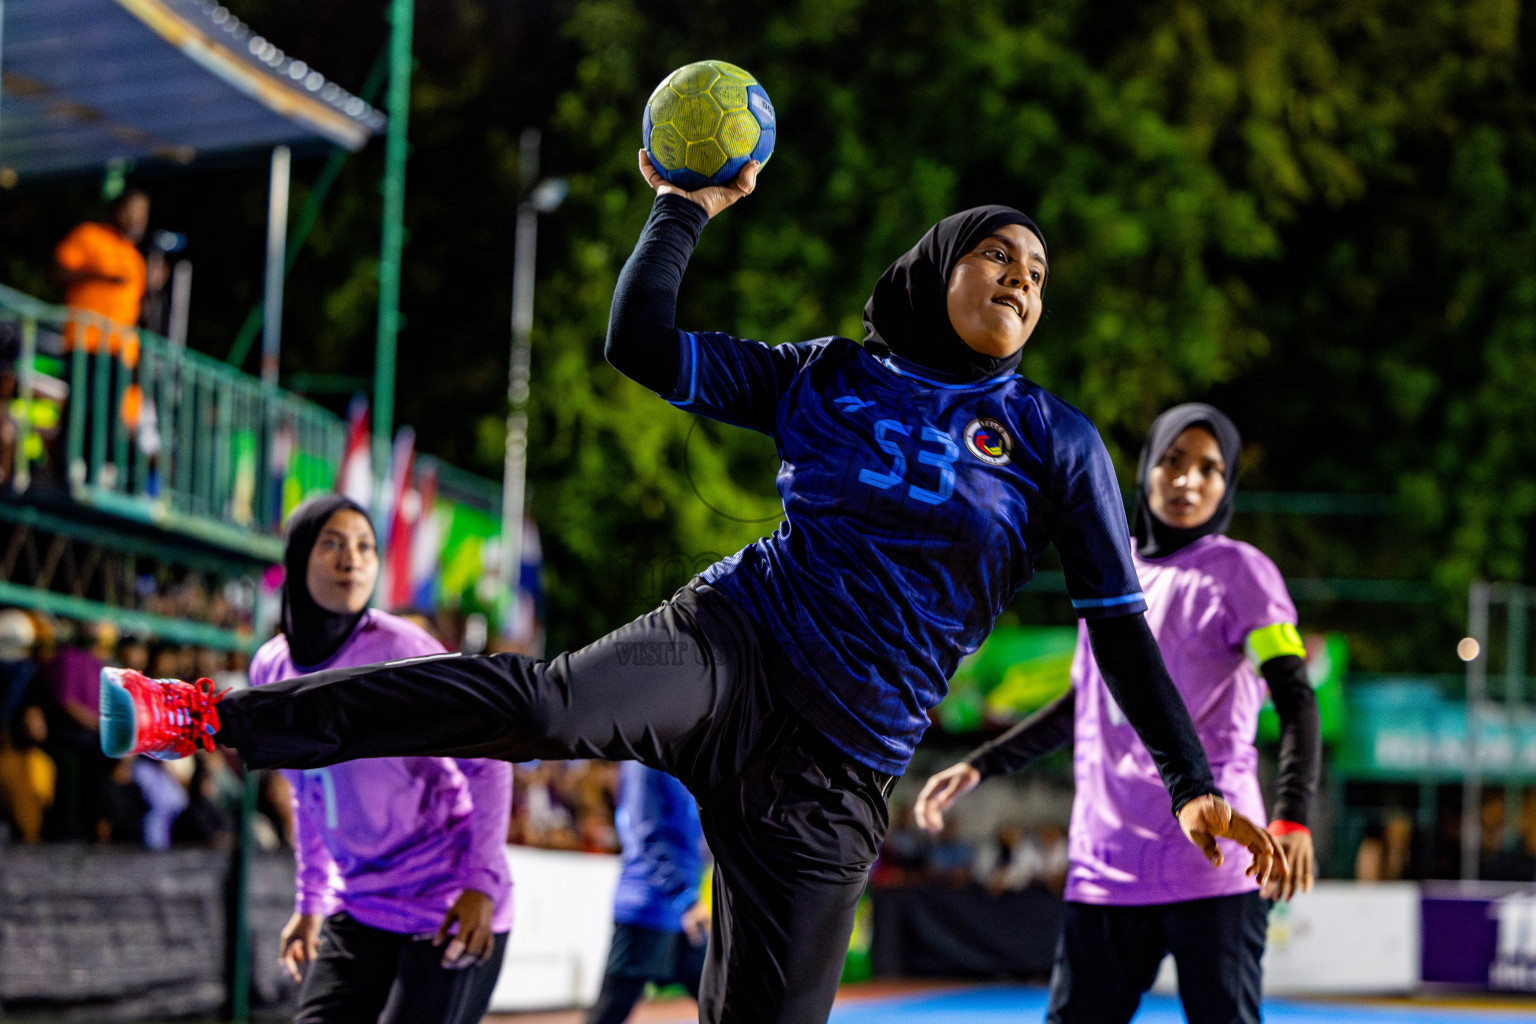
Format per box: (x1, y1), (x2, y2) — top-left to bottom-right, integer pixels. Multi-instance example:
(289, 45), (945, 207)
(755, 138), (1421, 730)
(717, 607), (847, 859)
(293, 910), (507, 1024)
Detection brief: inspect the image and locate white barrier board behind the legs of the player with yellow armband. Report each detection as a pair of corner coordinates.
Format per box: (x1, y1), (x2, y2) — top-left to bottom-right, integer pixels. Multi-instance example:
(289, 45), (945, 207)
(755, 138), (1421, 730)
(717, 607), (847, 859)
(1154, 881), (1421, 995)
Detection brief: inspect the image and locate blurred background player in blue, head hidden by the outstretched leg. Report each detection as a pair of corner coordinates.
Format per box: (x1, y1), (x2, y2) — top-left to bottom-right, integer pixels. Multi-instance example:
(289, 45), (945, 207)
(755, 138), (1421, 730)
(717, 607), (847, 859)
(587, 761), (710, 1024)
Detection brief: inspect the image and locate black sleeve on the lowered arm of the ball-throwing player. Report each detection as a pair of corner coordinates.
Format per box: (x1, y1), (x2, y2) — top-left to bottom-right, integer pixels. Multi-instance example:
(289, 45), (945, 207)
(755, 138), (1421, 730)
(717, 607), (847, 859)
(1087, 614), (1221, 814)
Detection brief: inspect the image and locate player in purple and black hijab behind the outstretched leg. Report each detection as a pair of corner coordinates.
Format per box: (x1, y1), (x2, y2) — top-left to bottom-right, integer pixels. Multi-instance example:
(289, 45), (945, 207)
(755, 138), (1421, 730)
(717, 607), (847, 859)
(250, 494), (511, 1024)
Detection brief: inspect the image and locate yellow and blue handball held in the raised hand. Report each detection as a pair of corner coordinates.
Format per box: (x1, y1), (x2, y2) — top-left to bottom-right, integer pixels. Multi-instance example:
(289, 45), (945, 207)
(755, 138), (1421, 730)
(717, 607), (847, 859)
(641, 60), (774, 192)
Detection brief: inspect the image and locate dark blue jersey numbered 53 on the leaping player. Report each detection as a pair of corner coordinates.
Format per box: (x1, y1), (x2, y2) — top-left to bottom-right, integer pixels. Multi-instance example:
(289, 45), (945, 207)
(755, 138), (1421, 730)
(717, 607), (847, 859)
(664, 332), (1146, 774)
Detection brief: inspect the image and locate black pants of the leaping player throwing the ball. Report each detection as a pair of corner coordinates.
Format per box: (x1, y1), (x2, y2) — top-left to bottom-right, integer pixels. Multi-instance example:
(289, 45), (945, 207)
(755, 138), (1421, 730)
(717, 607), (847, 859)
(218, 580), (894, 1024)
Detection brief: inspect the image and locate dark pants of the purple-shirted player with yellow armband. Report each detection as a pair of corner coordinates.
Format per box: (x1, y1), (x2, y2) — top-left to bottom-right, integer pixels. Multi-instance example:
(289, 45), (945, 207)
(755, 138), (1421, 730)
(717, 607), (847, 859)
(1046, 892), (1269, 1024)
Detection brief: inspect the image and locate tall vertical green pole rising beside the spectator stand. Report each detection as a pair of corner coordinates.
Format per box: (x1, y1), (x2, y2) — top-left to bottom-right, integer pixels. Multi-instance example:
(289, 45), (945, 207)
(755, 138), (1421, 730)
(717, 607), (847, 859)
(373, 0), (416, 516)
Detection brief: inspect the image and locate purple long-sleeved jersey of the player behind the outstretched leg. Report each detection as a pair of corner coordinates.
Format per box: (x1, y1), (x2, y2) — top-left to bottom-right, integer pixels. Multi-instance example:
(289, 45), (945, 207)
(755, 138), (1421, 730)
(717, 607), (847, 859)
(250, 611), (511, 935)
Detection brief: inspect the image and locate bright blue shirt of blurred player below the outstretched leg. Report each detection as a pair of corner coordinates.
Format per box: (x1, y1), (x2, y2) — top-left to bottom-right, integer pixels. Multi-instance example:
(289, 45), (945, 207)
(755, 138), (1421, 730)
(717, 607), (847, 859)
(613, 761), (703, 932)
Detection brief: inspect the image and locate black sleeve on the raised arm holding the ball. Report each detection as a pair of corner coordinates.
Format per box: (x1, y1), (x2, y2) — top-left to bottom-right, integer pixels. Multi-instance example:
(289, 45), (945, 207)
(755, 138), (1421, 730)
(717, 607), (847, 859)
(604, 195), (710, 395)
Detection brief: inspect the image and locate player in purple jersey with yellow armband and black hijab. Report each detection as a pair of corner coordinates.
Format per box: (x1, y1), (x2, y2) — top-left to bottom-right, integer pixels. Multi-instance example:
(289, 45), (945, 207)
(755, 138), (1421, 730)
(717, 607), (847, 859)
(915, 404), (1321, 1024)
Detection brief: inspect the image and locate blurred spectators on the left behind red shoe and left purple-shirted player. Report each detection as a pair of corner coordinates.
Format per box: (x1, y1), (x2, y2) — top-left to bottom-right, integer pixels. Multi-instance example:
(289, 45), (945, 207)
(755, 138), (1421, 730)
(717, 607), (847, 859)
(0, 607), (619, 854)
